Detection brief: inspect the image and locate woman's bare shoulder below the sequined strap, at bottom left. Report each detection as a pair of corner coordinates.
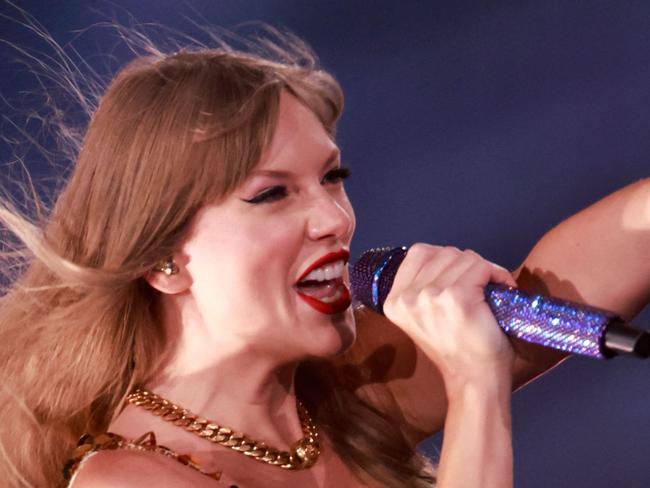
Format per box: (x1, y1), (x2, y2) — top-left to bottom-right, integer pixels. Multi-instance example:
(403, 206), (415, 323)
(69, 449), (224, 488)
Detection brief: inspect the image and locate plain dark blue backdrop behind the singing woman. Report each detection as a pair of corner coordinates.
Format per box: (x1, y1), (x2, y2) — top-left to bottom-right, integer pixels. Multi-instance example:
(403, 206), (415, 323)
(0, 0), (650, 488)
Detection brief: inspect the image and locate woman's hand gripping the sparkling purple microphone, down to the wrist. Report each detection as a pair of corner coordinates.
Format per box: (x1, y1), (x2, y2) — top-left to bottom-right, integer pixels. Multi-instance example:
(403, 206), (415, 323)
(384, 244), (516, 394)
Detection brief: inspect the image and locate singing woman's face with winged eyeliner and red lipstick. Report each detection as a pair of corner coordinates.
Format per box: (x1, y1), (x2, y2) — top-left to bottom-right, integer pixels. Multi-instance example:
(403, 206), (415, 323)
(182, 93), (355, 360)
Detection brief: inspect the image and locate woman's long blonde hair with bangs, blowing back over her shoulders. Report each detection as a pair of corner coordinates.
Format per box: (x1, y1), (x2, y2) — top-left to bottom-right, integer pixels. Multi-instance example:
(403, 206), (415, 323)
(0, 23), (430, 487)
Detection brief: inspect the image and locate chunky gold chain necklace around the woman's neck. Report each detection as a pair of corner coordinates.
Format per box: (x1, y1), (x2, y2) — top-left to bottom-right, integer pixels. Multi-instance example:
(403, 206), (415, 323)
(126, 388), (320, 469)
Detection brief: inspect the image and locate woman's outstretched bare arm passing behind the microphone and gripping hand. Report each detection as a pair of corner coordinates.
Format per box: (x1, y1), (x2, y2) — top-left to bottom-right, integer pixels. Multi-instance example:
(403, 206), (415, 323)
(344, 179), (650, 442)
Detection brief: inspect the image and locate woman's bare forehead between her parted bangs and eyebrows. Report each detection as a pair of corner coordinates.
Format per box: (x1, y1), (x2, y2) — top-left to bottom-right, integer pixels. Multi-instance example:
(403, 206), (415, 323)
(251, 91), (338, 175)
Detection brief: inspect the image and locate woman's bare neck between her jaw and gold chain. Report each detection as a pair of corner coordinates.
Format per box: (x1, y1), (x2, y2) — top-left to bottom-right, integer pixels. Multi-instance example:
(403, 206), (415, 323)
(144, 296), (303, 450)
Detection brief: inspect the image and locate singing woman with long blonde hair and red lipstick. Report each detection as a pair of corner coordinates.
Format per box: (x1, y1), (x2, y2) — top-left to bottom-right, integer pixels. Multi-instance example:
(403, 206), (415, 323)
(0, 32), (650, 488)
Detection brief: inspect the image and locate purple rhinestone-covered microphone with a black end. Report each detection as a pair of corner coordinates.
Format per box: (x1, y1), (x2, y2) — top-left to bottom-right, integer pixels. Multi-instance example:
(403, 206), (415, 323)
(350, 247), (650, 359)
